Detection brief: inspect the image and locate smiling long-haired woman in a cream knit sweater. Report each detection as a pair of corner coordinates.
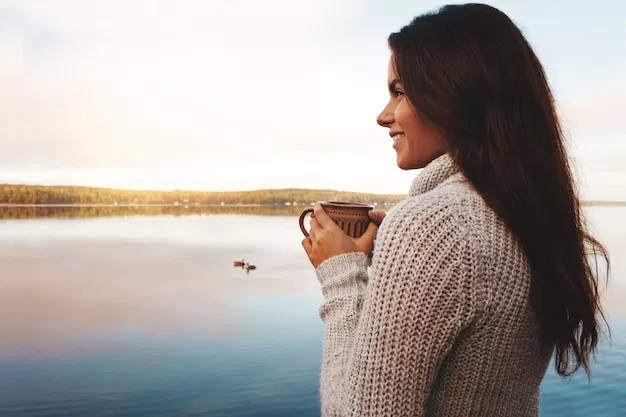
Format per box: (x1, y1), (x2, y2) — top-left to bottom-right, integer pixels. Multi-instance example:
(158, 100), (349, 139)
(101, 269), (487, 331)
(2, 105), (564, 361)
(302, 4), (608, 417)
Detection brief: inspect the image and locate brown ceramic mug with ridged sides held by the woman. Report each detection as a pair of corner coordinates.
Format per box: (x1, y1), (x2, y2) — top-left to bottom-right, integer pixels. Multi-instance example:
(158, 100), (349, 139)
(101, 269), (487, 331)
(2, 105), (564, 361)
(298, 201), (374, 238)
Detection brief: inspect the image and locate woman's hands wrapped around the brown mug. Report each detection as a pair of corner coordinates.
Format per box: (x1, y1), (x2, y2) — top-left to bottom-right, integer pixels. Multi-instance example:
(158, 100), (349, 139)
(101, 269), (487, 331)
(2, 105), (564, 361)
(302, 203), (385, 268)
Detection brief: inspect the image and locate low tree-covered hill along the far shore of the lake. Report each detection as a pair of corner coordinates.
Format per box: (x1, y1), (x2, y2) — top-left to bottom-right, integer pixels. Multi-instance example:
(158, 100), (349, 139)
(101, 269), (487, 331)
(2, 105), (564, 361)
(0, 184), (404, 205)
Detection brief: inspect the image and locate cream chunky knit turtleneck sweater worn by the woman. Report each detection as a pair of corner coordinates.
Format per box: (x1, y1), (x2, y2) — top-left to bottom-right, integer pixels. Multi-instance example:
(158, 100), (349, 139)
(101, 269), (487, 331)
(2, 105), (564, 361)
(316, 154), (550, 417)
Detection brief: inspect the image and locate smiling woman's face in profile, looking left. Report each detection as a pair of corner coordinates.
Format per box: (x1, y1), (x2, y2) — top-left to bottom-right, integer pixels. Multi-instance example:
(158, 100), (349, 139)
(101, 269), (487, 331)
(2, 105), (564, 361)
(376, 55), (446, 169)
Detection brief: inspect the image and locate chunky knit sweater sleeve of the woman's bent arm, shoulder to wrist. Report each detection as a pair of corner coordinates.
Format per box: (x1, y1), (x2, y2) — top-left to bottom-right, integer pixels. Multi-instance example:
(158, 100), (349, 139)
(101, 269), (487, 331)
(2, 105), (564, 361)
(316, 200), (476, 417)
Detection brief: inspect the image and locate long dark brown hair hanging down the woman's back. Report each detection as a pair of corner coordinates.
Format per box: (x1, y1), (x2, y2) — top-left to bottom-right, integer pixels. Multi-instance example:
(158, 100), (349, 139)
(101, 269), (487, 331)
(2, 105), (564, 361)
(389, 4), (609, 376)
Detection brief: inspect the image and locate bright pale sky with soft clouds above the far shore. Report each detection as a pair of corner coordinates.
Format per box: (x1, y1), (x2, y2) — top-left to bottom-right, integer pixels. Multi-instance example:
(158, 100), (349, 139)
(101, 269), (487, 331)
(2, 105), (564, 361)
(0, 0), (626, 201)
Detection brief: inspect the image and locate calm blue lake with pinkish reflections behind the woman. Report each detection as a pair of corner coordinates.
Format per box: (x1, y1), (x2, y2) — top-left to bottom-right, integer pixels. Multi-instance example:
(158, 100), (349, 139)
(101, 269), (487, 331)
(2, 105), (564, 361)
(0, 207), (626, 417)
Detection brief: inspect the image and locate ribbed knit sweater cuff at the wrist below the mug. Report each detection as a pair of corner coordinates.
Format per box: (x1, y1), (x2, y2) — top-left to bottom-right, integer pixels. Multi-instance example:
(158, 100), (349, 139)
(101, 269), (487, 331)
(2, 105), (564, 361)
(315, 252), (369, 298)
